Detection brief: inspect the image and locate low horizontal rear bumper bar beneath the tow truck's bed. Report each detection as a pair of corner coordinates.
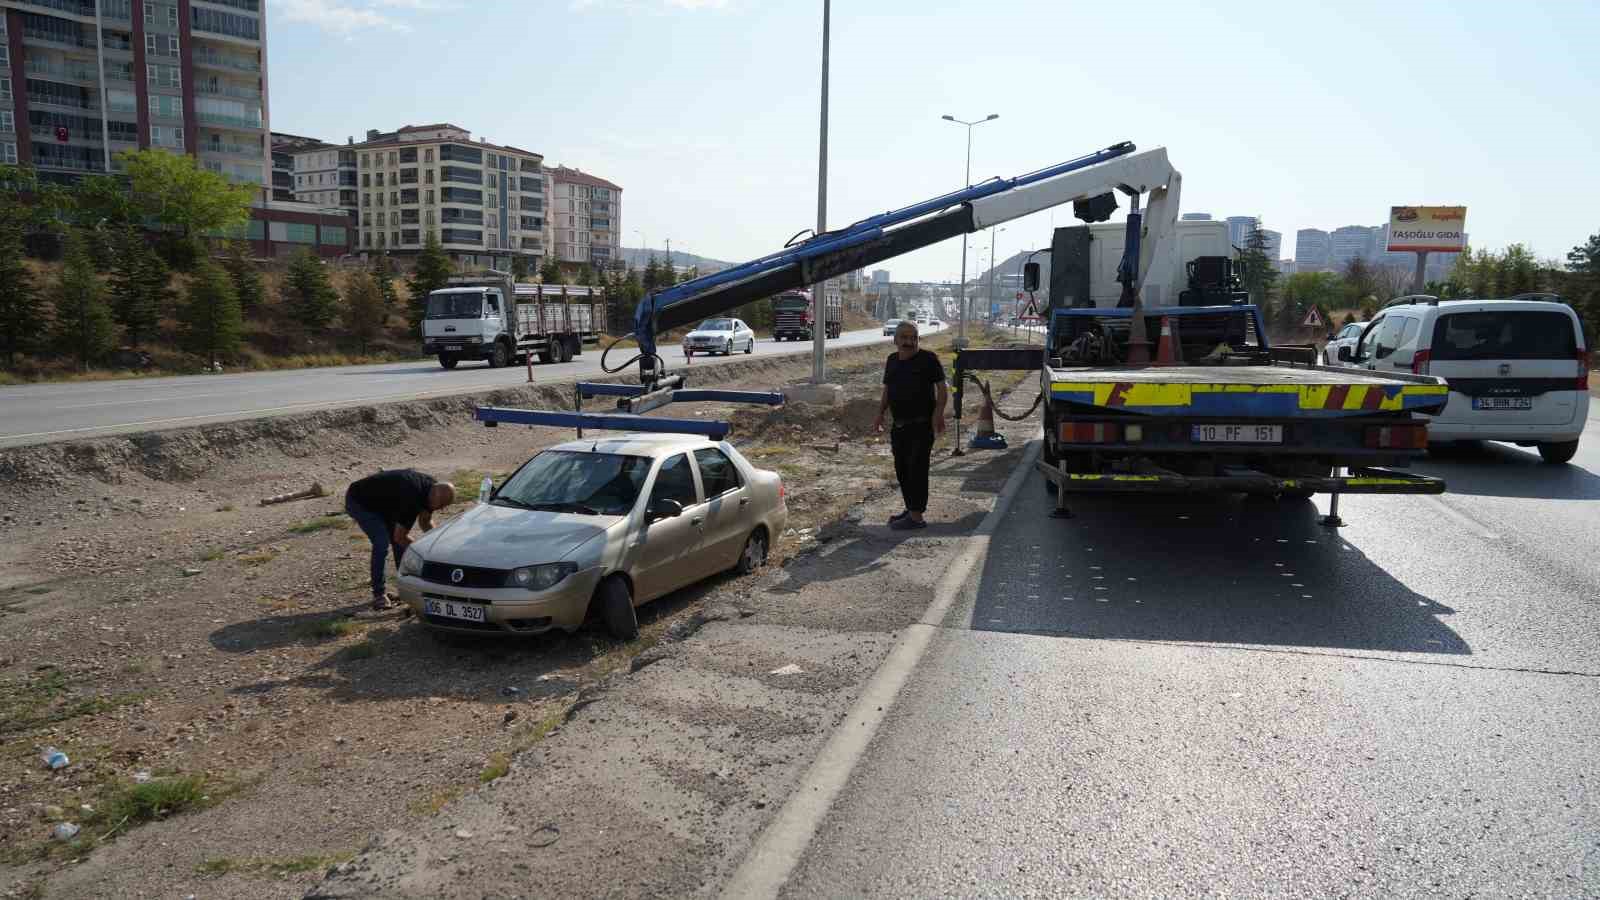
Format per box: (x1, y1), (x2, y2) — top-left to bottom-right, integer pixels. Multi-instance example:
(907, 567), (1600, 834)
(1034, 460), (1445, 493)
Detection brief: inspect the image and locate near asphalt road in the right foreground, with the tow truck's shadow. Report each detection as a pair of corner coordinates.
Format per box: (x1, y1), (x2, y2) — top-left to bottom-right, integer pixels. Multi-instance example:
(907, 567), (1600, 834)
(784, 408), (1600, 897)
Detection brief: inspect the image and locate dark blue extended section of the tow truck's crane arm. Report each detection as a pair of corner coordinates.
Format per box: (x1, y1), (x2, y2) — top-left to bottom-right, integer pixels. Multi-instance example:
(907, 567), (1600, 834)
(634, 141), (1134, 368)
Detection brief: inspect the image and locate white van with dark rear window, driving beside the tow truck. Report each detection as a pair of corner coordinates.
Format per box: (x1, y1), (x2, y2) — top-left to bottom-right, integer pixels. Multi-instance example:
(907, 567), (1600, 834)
(1339, 293), (1589, 463)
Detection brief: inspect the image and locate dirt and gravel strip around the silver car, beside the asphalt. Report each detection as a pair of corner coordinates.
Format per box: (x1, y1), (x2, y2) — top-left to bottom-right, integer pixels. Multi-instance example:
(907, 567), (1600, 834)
(0, 336), (1037, 897)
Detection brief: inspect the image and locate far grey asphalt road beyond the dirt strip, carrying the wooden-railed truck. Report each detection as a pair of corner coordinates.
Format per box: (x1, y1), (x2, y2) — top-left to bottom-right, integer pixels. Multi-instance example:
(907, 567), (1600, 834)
(0, 328), (934, 447)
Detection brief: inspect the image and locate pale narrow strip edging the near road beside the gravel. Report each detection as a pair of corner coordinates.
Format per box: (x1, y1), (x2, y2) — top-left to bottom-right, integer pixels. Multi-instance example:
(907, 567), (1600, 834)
(722, 440), (1040, 900)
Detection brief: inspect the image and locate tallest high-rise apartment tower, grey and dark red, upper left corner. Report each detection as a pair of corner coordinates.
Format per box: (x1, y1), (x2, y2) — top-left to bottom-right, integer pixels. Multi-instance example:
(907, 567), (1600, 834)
(0, 0), (272, 185)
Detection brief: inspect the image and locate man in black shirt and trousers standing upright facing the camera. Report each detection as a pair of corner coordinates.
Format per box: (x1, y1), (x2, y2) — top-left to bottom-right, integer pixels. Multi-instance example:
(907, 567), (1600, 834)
(872, 322), (949, 530)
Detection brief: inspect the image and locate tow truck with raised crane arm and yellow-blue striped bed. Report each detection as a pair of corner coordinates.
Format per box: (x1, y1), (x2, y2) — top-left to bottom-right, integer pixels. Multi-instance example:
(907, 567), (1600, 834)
(477, 136), (1448, 525)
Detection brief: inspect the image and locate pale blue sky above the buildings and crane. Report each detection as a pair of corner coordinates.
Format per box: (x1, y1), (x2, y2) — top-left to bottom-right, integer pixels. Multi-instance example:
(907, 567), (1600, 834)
(267, 0), (1600, 280)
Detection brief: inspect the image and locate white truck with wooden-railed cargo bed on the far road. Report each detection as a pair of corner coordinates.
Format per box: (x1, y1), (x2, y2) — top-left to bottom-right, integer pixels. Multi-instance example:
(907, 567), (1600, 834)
(422, 272), (606, 368)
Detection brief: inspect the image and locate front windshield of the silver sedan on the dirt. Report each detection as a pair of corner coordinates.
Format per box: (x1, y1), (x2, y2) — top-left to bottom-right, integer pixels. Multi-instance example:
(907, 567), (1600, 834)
(493, 450), (650, 516)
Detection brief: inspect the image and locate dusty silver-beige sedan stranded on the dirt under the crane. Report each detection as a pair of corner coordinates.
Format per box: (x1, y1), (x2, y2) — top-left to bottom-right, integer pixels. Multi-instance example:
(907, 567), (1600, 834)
(400, 434), (789, 639)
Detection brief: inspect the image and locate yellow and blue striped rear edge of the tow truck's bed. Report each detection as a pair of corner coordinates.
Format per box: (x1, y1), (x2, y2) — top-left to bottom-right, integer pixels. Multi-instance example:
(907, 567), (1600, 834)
(1050, 381), (1450, 418)
